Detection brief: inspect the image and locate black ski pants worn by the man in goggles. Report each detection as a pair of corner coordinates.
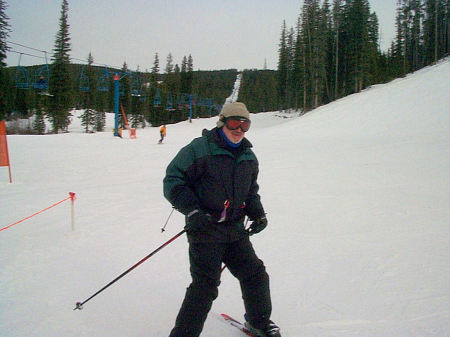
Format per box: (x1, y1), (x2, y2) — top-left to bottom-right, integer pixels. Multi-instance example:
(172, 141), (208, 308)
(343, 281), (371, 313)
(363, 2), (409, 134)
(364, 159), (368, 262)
(169, 236), (272, 337)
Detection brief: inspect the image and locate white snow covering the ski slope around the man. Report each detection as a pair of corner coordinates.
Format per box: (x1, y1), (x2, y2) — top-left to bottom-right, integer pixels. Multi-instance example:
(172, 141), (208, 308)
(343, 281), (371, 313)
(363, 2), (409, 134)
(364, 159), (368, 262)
(0, 59), (450, 337)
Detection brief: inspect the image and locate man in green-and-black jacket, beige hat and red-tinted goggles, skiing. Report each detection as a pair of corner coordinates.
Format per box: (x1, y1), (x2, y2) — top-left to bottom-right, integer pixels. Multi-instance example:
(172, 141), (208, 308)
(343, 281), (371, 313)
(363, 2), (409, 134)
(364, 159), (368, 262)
(164, 102), (281, 337)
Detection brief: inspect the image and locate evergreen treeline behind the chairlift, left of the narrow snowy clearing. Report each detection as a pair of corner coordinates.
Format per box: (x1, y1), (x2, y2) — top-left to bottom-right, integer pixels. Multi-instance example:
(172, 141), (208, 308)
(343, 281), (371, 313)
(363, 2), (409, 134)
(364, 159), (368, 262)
(0, 0), (237, 134)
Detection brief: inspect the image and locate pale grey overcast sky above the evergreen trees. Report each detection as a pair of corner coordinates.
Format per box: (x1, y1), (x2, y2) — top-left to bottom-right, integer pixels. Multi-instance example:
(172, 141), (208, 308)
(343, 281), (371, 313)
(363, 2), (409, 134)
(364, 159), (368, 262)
(6, 0), (396, 72)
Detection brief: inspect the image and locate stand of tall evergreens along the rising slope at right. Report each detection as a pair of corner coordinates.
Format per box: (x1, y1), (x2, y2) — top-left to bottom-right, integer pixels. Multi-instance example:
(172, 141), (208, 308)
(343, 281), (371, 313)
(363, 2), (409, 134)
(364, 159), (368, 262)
(277, 0), (449, 111)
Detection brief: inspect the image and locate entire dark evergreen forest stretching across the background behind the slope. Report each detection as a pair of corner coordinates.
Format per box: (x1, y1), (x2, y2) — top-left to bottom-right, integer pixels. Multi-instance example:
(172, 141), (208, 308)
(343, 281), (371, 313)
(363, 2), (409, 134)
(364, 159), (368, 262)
(0, 0), (449, 134)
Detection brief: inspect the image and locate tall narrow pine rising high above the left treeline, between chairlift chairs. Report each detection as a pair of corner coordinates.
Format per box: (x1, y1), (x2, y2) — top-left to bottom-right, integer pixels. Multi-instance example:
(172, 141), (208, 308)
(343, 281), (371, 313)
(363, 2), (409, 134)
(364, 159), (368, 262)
(48, 0), (72, 133)
